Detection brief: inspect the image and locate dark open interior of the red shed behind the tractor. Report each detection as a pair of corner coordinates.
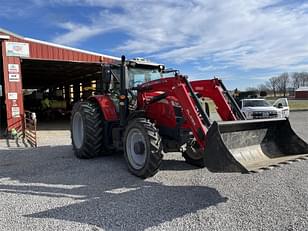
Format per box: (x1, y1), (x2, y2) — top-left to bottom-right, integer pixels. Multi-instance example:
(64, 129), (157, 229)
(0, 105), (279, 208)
(21, 59), (102, 130)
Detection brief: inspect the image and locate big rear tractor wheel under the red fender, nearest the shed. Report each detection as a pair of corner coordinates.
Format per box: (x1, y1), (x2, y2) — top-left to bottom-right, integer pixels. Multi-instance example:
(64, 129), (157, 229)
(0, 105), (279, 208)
(71, 102), (107, 159)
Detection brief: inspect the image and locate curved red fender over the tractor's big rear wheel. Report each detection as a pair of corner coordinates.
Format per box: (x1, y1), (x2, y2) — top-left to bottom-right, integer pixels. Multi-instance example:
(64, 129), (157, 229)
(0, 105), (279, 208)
(89, 95), (119, 121)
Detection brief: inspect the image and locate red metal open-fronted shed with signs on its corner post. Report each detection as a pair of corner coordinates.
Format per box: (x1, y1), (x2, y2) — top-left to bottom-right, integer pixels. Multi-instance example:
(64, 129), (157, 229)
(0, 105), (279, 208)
(0, 29), (119, 139)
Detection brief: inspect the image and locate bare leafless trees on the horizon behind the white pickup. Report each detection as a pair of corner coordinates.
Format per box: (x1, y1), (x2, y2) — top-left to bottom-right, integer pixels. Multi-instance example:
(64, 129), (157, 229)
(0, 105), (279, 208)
(247, 72), (308, 97)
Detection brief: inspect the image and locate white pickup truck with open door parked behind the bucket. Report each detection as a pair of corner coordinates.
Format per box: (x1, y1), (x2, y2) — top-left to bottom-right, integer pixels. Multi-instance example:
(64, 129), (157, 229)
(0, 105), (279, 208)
(240, 98), (290, 119)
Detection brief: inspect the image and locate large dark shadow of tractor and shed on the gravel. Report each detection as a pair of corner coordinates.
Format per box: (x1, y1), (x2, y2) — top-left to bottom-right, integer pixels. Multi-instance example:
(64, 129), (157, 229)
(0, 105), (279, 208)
(0, 146), (227, 230)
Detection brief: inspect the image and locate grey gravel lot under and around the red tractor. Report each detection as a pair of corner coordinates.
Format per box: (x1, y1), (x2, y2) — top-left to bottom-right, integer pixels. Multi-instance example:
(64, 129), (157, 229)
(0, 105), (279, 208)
(0, 112), (308, 231)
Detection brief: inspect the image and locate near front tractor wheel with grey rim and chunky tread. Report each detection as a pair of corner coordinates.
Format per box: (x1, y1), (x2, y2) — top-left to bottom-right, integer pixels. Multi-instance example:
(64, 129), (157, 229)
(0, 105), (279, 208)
(124, 118), (163, 178)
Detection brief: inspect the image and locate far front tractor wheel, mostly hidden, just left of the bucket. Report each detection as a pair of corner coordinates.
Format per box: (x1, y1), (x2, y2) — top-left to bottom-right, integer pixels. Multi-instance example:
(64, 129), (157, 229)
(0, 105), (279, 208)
(182, 143), (205, 168)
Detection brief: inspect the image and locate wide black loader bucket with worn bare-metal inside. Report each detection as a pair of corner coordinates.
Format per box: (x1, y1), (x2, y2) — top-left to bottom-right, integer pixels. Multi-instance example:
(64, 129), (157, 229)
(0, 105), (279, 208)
(203, 118), (308, 173)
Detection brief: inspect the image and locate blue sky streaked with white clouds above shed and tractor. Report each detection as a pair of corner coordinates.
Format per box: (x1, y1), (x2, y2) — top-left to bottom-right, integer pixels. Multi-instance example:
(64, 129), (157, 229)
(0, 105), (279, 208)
(0, 0), (308, 89)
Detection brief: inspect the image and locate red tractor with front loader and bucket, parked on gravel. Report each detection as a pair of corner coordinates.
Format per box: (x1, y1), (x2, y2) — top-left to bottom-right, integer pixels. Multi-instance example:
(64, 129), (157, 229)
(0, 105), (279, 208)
(71, 56), (308, 178)
